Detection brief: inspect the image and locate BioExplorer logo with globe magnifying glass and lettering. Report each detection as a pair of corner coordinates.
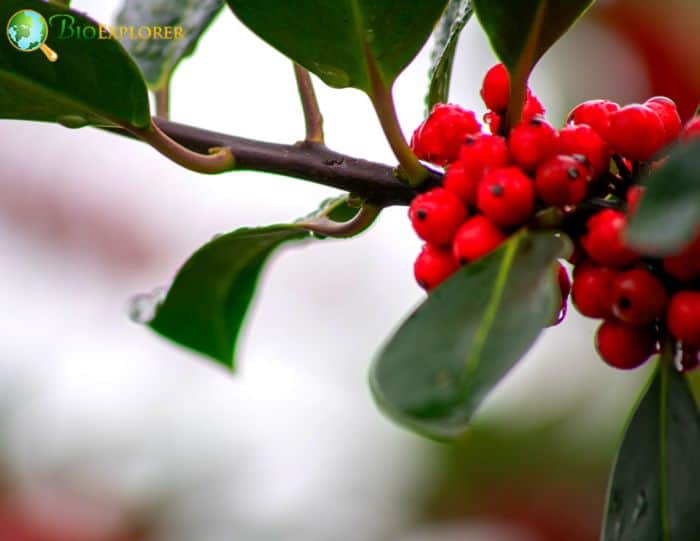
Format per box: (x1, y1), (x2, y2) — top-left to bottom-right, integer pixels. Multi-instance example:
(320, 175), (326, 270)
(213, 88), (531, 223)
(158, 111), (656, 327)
(7, 9), (185, 62)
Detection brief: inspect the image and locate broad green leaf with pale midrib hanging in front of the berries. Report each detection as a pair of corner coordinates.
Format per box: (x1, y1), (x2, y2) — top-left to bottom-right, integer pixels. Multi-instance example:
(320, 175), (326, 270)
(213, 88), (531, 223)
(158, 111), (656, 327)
(370, 231), (569, 439)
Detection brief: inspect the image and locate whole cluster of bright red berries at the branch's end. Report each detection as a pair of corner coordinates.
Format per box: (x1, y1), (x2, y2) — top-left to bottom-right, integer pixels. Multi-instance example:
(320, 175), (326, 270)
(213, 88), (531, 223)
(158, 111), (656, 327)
(409, 64), (700, 370)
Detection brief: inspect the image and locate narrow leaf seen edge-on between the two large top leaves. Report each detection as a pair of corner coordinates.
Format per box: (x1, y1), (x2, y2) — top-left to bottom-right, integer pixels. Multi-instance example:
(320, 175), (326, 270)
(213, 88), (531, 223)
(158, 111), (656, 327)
(425, 0), (473, 114)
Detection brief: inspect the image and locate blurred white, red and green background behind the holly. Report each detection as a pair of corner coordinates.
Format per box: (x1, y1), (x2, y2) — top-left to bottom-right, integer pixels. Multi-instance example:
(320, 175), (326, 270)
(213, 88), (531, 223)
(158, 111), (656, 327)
(0, 0), (700, 541)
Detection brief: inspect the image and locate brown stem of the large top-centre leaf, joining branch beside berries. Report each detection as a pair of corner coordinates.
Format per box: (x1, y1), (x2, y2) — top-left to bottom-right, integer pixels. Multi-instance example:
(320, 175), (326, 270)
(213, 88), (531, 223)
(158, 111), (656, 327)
(365, 53), (429, 187)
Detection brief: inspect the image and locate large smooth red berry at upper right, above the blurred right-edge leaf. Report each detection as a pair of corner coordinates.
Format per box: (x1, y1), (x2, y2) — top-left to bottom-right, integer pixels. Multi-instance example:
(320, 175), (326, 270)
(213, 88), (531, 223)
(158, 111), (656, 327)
(608, 104), (666, 161)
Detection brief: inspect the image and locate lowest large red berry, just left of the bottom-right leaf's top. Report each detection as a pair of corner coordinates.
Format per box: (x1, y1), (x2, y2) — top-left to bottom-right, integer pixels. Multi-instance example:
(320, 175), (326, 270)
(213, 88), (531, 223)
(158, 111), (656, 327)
(596, 319), (656, 370)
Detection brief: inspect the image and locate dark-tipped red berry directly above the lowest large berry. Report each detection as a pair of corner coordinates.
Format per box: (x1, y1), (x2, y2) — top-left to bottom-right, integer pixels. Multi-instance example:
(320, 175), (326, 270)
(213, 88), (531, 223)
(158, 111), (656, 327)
(612, 269), (668, 325)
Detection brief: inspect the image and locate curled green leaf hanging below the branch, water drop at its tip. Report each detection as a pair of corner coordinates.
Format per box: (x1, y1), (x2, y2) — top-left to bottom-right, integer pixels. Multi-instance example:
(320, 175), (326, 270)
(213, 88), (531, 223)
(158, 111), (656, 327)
(142, 225), (310, 369)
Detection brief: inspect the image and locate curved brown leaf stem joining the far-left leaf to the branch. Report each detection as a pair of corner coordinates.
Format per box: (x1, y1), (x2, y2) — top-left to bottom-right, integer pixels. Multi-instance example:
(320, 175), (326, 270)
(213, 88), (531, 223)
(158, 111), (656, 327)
(128, 119), (236, 175)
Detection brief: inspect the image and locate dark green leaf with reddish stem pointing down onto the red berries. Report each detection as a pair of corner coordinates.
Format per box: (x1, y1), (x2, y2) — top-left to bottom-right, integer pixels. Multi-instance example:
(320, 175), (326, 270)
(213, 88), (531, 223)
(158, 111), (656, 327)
(472, 0), (593, 125)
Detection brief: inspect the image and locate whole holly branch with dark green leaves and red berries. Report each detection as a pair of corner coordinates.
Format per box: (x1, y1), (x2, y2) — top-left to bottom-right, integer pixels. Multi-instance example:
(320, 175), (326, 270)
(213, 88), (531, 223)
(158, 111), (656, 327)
(0, 0), (700, 541)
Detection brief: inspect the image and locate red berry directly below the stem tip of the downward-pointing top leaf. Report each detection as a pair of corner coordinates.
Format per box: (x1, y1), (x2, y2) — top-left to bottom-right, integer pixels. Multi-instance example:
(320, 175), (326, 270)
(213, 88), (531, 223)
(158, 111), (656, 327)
(508, 116), (557, 171)
